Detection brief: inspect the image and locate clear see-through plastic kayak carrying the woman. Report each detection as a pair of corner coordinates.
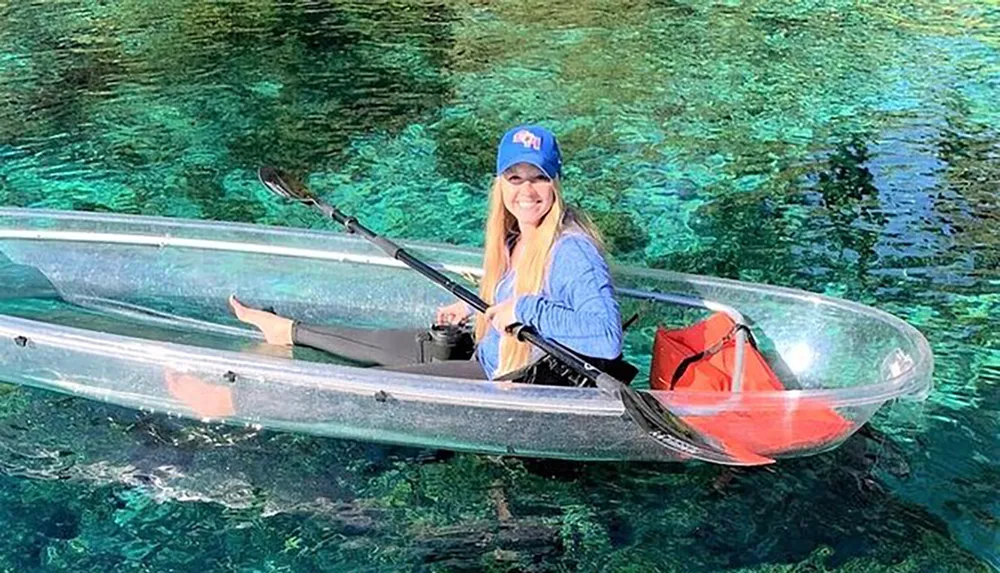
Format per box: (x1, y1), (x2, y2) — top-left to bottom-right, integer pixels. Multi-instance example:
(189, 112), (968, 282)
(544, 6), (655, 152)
(0, 209), (933, 461)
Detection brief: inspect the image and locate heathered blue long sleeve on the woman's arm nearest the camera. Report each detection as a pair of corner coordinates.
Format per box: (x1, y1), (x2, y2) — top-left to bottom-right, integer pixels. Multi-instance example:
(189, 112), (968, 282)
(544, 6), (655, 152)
(514, 235), (622, 359)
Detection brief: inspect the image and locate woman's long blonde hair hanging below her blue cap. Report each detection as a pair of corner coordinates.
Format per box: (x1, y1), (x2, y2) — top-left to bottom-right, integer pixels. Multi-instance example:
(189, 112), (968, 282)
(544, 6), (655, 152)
(476, 176), (604, 376)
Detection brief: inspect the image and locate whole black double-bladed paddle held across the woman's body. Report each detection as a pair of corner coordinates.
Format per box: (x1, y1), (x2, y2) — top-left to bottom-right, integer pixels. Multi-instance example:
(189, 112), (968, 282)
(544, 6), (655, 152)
(257, 167), (774, 466)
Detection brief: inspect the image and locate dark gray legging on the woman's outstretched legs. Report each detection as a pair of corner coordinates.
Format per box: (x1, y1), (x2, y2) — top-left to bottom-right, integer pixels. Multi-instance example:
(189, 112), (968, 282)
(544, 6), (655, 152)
(292, 321), (486, 380)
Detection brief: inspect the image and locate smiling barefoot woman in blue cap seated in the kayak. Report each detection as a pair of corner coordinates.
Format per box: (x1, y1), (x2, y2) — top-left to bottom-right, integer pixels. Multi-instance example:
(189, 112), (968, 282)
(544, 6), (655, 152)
(230, 125), (623, 385)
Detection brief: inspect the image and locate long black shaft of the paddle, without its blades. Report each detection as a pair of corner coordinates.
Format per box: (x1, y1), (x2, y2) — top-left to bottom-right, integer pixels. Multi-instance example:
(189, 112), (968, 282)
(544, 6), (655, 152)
(311, 200), (625, 391)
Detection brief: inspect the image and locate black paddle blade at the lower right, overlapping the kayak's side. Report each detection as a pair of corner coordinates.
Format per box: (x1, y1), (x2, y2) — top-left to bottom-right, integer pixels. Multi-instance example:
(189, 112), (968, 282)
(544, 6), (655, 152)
(621, 386), (774, 466)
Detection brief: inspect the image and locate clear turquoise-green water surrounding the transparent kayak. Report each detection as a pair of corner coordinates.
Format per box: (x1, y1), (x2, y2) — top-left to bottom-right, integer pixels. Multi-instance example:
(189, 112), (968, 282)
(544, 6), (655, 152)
(0, 0), (1000, 571)
